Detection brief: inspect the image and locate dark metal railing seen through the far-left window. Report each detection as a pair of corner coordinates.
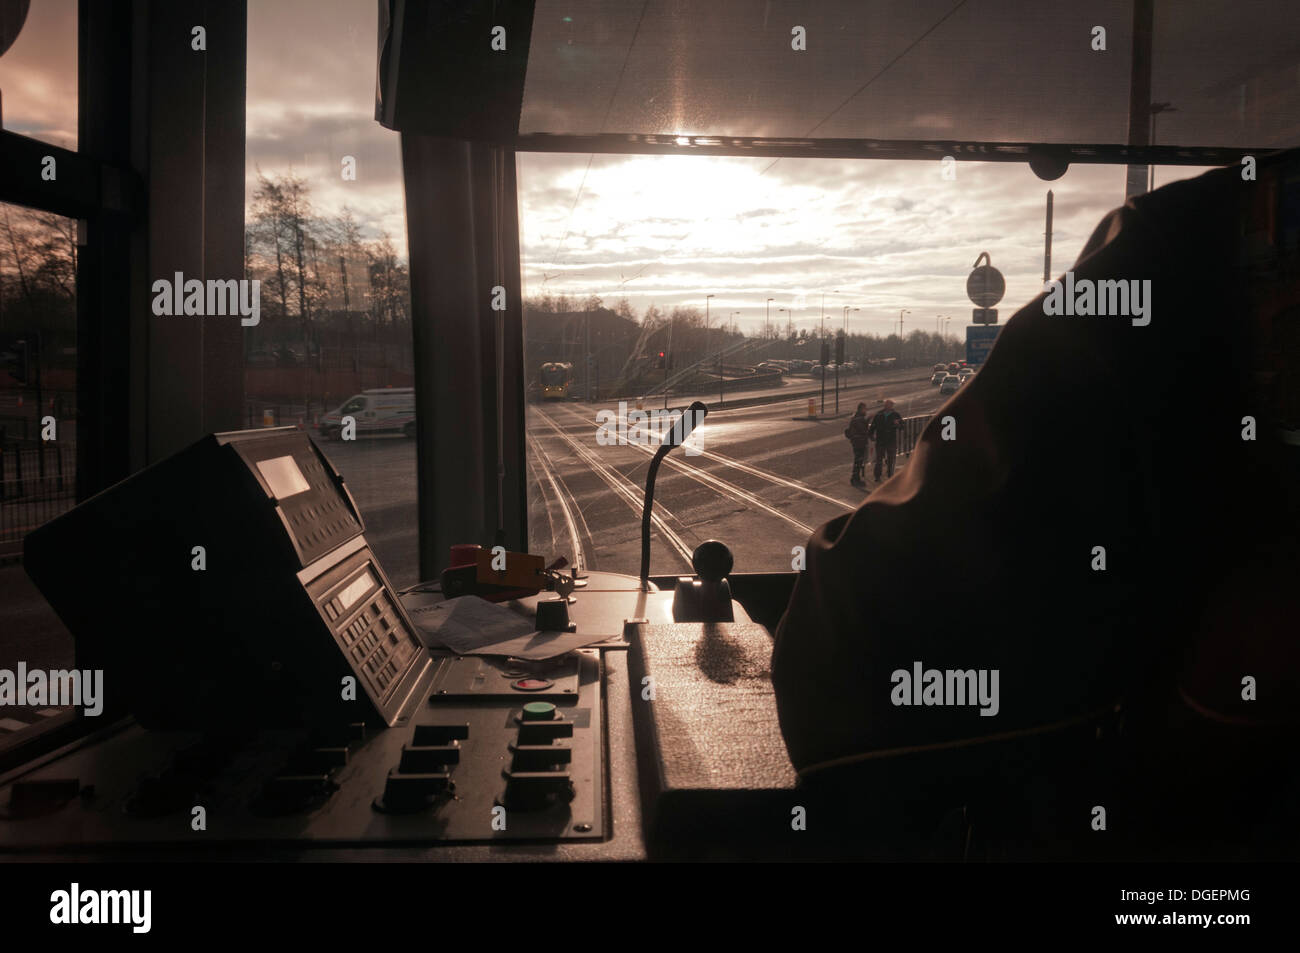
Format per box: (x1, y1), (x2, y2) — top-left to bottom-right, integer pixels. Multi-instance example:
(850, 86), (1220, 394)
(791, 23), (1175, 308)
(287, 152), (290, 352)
(0, 443), (77, 542)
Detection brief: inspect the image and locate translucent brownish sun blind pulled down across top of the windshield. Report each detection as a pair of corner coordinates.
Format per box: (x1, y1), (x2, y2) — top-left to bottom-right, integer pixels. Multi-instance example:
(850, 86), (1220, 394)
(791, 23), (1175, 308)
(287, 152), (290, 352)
(520, 0), (1300, 148)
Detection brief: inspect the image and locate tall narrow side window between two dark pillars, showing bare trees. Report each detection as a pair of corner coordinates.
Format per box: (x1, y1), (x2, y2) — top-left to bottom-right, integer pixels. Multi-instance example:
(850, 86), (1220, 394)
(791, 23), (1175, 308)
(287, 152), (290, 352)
(239, 0), (410, 588)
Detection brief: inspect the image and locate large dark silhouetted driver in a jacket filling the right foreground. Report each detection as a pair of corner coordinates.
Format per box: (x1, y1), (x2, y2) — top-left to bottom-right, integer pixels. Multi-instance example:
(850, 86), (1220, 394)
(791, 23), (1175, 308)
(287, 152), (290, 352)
(772, 151), (1300, 780)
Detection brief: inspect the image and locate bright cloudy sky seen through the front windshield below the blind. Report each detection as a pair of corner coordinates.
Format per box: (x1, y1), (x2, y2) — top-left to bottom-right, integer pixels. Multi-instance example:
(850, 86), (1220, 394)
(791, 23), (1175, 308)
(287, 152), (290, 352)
(520, 148), (1159, 334)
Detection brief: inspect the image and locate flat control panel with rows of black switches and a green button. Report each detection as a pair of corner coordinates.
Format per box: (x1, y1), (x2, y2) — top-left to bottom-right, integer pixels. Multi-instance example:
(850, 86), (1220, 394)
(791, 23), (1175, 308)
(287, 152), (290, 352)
(0, 649), (623, 850)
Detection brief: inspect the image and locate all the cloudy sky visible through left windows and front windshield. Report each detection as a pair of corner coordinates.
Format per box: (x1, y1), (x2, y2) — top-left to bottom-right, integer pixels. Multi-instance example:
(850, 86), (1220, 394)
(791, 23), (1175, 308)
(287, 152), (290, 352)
(0, 0), (1222, 334)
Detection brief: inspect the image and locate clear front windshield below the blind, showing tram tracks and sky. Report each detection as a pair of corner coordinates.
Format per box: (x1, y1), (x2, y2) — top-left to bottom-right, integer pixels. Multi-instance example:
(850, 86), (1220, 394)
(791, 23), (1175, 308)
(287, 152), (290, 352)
(519, 153), (1199, 575)
